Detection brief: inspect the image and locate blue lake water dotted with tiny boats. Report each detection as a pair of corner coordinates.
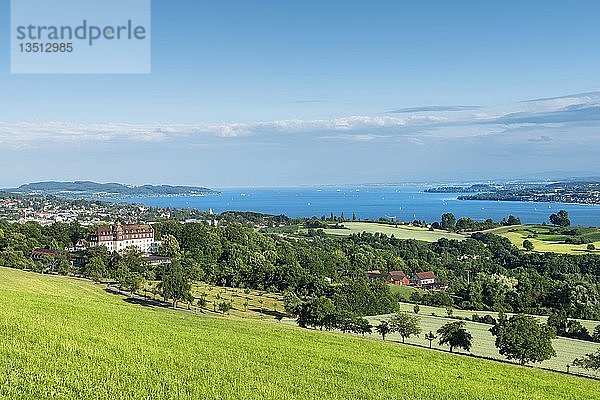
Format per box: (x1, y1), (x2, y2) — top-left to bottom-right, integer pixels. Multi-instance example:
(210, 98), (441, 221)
(120, 185), (600, 226)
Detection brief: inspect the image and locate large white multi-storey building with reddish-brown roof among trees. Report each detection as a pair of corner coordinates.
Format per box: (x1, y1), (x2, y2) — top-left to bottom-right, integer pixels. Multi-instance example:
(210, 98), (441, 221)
(89, 224), (154, 254)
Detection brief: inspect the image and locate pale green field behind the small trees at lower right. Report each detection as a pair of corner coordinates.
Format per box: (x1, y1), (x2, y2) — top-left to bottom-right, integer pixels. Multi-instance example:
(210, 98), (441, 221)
(382, 303), (600, 378)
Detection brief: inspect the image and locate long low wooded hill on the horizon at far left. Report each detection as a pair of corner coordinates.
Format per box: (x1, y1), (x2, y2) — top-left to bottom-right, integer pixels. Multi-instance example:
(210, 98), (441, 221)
(3, 181), (219, 199)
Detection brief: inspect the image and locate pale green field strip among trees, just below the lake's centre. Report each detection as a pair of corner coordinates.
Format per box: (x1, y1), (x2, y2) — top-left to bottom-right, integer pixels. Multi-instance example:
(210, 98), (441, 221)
(324, 222), (465, 242)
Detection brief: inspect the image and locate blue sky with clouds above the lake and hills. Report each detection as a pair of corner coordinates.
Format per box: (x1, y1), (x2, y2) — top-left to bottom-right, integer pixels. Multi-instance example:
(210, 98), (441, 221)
(0, 0), (600, 188)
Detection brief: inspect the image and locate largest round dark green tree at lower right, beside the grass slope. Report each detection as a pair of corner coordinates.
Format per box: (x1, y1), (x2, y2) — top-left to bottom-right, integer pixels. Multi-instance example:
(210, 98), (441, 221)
(490, 314), (556, 365)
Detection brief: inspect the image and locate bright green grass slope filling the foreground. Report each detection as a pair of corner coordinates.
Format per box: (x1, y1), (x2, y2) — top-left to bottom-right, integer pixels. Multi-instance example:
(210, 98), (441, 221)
(0, 268), (600, 400)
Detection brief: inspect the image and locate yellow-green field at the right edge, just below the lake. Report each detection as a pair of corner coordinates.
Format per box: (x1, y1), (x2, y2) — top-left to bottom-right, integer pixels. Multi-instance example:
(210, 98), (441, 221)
(486, 225), (600, 254)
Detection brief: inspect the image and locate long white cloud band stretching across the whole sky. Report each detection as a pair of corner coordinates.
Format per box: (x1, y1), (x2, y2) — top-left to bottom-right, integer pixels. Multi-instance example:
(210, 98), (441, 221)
(0, 92), (600, 148)
